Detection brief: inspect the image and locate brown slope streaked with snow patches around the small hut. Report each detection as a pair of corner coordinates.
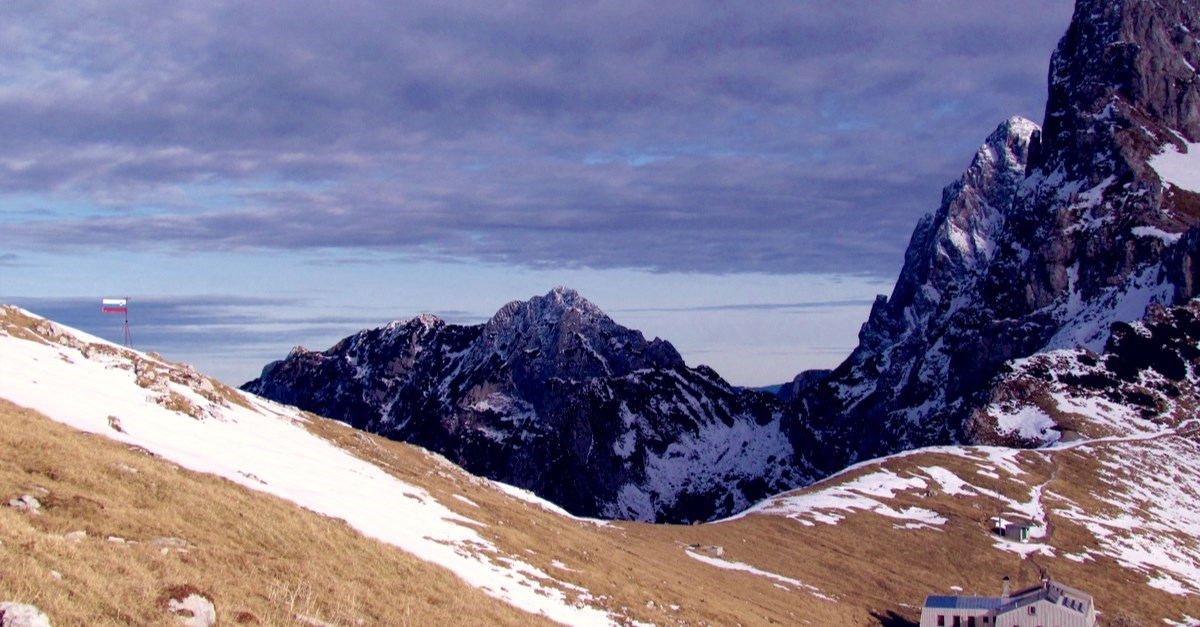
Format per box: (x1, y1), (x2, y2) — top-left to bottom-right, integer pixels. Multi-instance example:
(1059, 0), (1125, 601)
(719, 417), (1200, 626)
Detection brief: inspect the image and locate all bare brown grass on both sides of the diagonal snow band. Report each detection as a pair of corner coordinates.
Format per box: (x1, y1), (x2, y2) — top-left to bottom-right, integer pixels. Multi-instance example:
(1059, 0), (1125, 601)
(0, 389), (1200, 625)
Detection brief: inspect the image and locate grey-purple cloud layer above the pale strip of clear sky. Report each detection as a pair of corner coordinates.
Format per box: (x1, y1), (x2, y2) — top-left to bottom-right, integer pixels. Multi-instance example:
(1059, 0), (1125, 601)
(0, 0), (1070, 274)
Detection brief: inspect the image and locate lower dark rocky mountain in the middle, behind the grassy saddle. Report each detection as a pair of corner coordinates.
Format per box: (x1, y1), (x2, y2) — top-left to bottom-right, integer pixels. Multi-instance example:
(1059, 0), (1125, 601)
(244, 288), (812, 523)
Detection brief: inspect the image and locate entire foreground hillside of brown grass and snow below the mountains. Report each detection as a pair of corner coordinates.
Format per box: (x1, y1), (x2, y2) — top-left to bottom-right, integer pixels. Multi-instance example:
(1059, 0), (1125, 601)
(0, 307), (1200, 625)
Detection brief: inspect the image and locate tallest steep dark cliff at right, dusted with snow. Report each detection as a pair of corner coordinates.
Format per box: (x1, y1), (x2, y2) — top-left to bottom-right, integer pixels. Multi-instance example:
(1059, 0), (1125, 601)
(793, 0), (1200, 471)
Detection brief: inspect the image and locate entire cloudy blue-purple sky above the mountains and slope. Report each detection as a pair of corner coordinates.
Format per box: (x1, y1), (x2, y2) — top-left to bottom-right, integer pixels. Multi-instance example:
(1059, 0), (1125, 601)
(0, 0), (1073, 386)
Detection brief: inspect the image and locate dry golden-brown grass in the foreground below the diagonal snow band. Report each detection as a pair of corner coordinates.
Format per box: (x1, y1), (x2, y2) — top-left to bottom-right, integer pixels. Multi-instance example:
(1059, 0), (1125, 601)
(0, 400), (547, 625)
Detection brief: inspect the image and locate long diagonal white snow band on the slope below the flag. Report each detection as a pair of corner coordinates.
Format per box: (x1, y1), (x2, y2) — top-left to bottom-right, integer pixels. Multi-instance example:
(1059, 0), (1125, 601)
(0, 306), (614, 625)
